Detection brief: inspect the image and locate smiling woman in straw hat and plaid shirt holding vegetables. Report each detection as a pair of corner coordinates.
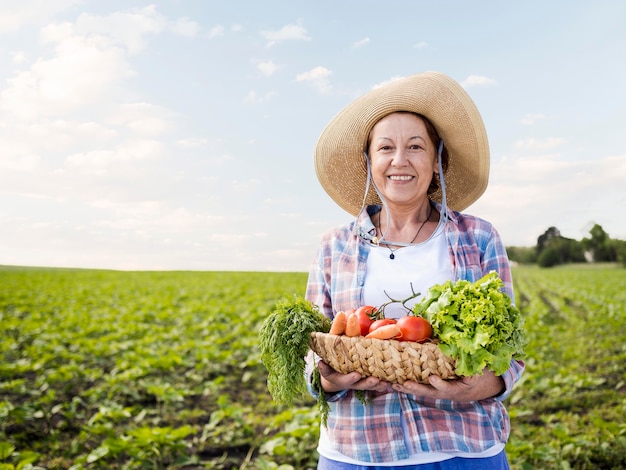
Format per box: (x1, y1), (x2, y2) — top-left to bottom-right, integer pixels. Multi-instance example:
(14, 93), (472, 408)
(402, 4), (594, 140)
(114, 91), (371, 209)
(306, 72), (524, 469)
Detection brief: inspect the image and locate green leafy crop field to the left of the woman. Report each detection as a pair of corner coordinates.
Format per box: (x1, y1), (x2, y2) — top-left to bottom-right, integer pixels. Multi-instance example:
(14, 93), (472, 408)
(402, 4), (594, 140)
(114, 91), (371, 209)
(0, 269), (312, 469)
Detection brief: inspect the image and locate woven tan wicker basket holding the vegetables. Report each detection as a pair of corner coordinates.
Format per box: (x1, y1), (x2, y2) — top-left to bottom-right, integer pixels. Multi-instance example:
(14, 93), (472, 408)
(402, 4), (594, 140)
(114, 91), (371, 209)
(311, 332), (457, 384)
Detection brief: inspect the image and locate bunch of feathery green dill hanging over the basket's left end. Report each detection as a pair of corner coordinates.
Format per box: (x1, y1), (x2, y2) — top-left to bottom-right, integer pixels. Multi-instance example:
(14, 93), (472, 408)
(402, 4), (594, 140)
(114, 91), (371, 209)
(259, 296), (331, 405)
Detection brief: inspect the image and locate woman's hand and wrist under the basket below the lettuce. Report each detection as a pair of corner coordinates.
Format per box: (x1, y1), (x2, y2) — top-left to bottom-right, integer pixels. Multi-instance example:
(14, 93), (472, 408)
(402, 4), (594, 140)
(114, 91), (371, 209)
(393, 369), (505, 401)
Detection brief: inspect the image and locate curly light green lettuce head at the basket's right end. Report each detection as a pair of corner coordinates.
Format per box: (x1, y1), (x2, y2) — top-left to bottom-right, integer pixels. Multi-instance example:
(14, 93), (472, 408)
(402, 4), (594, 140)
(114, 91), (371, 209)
(414, 271), (526, 376)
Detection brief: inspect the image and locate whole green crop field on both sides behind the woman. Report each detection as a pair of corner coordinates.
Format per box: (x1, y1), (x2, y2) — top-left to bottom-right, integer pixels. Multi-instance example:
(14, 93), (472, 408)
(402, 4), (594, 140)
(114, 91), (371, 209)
(0, 265), (626, 470)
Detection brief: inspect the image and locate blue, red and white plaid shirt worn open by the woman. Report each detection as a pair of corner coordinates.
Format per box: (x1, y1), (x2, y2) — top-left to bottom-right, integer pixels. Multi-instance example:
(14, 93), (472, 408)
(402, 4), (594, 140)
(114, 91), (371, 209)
(306, 206), (524, 462)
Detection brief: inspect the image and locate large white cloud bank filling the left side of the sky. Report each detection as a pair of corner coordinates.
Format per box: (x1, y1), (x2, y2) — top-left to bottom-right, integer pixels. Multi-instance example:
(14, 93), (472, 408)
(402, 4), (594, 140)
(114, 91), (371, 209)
(0, 2), (314, 269)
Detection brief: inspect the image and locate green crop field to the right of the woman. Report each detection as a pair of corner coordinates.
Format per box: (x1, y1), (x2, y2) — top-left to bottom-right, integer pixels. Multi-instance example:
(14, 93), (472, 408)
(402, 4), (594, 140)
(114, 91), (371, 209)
(507, 267), (626, 469)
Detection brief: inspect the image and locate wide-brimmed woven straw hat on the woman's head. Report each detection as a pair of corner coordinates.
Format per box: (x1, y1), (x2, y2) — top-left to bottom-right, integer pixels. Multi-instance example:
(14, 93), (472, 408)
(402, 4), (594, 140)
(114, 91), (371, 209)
(315, 72), (489, 215)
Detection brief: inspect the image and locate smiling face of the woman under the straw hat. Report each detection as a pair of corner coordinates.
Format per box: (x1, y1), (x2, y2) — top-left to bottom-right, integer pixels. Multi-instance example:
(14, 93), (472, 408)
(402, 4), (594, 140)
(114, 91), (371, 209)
(369, 113), (438, 204)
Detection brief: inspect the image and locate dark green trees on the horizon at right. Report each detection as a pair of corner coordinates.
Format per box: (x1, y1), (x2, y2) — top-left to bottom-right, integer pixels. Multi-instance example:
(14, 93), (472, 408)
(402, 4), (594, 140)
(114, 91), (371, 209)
(507, 224), (626, 268)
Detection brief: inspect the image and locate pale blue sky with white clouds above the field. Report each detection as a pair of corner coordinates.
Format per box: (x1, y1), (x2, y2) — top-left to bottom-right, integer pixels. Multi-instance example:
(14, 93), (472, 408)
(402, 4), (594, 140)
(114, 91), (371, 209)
(0, 0), (626, 272)
